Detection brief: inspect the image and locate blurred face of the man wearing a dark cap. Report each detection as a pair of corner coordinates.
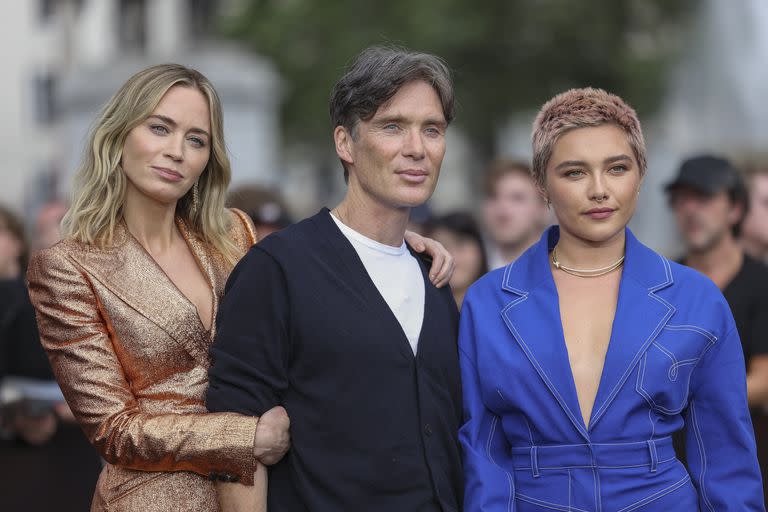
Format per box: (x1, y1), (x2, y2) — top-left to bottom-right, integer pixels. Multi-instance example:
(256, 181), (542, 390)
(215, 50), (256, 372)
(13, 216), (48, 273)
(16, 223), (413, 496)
(669, 186), (741, 253)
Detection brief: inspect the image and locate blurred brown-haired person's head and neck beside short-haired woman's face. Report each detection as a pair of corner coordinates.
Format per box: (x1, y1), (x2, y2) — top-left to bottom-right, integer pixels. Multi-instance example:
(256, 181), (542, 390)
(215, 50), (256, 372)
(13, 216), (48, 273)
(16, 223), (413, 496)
(482, 160), (548, 269)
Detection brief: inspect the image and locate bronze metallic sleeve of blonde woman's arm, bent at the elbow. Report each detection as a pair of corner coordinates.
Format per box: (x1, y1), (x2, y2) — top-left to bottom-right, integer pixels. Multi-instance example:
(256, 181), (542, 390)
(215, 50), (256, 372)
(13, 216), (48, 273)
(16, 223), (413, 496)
(28, 246), (288, 484)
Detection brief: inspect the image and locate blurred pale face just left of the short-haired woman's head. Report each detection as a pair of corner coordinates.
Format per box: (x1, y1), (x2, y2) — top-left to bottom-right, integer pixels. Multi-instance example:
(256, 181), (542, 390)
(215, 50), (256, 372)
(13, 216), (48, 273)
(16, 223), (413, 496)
(483, 172), (547, 246)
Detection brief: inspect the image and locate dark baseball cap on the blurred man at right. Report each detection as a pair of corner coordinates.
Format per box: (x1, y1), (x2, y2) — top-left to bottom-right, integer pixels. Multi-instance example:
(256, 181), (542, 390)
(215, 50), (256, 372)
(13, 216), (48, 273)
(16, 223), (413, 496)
(664, 155), (745, 196)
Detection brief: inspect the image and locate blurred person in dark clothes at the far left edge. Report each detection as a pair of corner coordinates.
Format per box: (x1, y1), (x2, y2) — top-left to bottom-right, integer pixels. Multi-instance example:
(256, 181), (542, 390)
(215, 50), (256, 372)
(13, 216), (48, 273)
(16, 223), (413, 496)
(0, 202), (101, 512)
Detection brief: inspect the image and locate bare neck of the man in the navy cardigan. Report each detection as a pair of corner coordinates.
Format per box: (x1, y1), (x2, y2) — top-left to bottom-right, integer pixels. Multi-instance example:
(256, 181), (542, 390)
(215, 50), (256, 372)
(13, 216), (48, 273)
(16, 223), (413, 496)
(331, 193), (411, 247)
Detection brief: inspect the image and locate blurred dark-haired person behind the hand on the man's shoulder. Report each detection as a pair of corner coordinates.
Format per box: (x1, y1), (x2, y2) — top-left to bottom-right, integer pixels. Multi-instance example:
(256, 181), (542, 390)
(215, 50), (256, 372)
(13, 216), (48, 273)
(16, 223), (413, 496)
(426, 211), (488, 309)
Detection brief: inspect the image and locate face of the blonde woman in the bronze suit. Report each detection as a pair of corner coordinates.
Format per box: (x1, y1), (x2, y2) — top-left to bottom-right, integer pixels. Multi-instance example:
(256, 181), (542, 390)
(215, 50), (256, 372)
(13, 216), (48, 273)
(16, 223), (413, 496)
(122, 86), (211, 208)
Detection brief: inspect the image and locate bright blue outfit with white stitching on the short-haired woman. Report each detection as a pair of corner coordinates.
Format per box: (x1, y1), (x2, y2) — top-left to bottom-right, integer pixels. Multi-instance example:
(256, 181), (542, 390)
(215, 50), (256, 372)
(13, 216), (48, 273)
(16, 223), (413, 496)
(459, 227), (765, 512)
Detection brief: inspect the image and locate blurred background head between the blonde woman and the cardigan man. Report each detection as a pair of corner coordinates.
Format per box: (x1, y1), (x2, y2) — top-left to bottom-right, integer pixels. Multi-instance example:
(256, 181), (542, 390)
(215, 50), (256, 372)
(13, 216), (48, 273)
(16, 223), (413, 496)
(227, 185), (293, 239)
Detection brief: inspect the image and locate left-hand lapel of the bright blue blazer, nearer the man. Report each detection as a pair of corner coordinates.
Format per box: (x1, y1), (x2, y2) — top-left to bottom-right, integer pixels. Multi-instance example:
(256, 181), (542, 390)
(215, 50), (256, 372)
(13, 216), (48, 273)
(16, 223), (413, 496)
(501, 228), (589, 441)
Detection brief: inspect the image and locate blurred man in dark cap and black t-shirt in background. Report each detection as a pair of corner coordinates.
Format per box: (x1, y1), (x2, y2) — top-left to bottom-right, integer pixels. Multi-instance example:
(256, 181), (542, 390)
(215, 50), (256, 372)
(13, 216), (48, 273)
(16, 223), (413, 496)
(666, 155), (768, 504)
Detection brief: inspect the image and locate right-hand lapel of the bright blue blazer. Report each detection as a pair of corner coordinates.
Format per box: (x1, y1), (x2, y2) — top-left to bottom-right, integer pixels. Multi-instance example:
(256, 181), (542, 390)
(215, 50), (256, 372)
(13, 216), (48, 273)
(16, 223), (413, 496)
(589, 229), (675, 430)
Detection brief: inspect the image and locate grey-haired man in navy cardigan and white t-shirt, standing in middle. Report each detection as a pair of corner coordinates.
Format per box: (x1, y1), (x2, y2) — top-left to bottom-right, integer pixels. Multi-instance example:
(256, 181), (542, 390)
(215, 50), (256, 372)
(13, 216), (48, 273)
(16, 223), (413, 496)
(207, 47), (462, 512)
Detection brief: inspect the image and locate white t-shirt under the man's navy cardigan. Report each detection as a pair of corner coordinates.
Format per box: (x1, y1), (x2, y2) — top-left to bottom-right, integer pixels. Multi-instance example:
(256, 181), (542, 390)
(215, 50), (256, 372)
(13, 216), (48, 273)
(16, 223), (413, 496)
(331, 214), (424, 355)
